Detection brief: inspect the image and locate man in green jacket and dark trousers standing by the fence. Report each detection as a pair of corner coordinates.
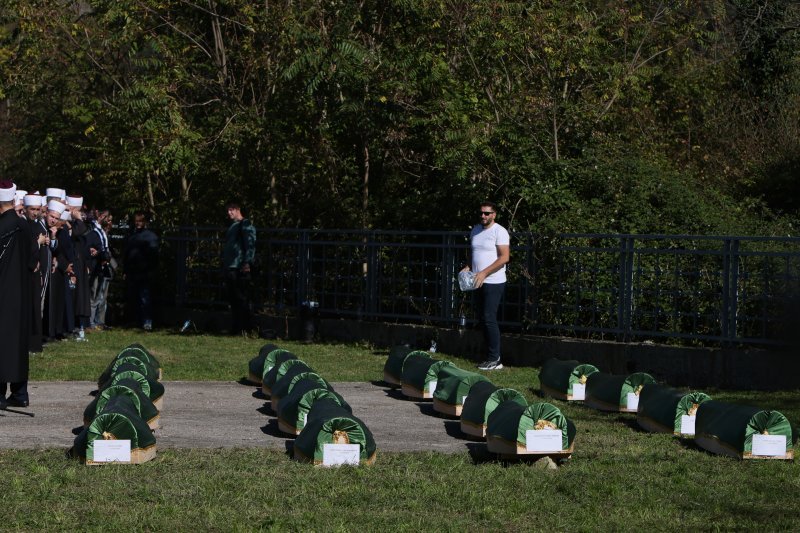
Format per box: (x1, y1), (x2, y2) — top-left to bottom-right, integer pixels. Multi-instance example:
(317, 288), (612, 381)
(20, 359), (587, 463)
(222, 202), (256, 335)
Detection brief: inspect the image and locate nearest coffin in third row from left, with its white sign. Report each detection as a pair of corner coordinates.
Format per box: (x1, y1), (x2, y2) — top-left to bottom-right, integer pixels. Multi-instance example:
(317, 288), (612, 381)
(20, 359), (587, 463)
(486, 400), (576, 457)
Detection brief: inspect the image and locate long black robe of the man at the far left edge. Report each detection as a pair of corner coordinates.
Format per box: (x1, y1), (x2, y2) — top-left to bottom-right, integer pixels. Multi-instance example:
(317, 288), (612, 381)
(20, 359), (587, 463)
(0, 209), (35, 383)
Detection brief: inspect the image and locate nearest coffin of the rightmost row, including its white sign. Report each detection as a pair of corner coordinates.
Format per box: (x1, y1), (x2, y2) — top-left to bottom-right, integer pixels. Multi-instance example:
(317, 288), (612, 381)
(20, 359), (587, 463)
(694, 400), (797, 459)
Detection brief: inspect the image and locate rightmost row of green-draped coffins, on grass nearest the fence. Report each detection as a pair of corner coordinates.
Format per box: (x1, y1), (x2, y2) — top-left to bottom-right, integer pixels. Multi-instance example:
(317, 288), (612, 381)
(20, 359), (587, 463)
(539, 359), (798, 459)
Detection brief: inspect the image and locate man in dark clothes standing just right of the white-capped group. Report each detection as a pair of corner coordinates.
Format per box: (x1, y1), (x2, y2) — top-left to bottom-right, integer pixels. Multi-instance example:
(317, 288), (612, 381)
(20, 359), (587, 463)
(123, 212), (158, 331)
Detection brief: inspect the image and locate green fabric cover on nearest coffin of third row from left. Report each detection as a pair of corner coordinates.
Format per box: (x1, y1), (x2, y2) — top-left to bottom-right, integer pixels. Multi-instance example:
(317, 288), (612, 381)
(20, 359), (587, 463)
(486, 400), (576, 450)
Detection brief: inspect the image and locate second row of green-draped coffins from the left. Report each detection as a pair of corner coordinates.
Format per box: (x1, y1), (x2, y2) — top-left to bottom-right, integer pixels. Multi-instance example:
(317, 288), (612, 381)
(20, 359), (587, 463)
(248, 344), (376, 464)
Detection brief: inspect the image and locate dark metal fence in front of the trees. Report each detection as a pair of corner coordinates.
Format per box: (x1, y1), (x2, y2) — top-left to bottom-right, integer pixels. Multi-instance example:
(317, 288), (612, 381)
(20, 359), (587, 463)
(136, 227), (800, 345)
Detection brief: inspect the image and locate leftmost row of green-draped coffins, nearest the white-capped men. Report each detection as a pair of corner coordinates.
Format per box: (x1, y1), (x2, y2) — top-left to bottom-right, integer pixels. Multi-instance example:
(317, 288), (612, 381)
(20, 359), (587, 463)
(70, 344), (164, 465)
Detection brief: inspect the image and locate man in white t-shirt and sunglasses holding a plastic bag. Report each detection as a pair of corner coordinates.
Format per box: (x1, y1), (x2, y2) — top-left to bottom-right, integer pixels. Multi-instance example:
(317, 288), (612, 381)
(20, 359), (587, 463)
(464, 202), (511, 370)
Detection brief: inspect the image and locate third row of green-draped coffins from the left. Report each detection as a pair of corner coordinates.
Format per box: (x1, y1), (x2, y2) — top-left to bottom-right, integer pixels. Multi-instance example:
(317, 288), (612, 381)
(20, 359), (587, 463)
(383, 346), (576, 457)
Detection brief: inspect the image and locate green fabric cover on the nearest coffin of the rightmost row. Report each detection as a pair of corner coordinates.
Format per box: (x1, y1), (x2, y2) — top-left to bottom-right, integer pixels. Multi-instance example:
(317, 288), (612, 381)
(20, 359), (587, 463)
(695, 400), (797, 454)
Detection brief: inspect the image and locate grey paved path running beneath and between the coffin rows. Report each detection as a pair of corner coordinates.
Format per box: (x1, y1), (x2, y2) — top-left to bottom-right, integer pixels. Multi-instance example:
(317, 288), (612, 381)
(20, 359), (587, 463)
(0, 381), (475, 453)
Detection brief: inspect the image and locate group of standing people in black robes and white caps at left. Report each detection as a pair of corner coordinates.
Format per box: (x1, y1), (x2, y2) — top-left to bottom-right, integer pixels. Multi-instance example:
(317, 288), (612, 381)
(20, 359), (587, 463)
(0, 180), (115, 408)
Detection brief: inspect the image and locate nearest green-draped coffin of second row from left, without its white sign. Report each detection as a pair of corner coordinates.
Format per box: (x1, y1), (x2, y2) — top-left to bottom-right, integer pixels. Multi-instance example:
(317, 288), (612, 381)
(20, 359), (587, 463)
(294, 399), (376, 464)
